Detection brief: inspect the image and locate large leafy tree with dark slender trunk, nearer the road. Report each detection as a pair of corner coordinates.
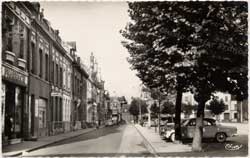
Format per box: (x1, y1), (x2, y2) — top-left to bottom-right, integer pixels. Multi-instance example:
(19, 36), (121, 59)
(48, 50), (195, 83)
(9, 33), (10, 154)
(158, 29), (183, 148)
(121, 2), (191, 140)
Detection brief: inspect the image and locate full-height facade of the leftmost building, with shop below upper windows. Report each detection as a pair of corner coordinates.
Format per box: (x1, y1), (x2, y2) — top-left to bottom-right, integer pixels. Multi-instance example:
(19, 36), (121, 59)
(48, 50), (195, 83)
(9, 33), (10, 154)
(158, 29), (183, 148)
(1, 2), (31, 143)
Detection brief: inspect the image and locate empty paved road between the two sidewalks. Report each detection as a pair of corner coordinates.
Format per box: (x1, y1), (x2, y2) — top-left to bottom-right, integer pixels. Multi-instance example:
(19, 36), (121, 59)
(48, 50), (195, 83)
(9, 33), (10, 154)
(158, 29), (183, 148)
(23, 125), (153, 157)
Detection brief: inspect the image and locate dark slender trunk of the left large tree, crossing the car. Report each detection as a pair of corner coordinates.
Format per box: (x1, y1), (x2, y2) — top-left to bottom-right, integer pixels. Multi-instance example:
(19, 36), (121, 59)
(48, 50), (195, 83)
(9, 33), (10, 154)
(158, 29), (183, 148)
(174, 88), (182, 141)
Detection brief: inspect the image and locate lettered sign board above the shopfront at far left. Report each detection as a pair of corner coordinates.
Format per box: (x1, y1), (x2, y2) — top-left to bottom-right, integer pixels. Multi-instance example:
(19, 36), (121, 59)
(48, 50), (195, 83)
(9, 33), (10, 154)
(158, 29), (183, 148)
(2, 66), (28, 85)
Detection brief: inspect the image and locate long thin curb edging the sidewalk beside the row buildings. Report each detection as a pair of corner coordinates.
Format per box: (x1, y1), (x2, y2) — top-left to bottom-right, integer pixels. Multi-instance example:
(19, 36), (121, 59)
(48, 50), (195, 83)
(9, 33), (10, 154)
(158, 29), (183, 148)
(2, 127), (97, 157)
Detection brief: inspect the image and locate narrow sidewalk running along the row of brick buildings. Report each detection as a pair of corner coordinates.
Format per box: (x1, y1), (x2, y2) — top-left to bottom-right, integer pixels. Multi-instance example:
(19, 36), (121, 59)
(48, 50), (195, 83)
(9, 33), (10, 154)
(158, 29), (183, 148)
(2, 128), (95, 156)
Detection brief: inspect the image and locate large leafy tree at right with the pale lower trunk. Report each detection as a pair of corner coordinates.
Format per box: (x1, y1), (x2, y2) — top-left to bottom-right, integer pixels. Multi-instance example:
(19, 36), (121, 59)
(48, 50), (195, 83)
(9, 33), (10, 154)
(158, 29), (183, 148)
(185, 2), (248, 151)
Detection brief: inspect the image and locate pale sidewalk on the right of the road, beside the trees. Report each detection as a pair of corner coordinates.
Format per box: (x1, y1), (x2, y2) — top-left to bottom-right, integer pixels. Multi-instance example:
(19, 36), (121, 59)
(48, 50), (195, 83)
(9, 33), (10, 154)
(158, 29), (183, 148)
(135, 124), (191, 155)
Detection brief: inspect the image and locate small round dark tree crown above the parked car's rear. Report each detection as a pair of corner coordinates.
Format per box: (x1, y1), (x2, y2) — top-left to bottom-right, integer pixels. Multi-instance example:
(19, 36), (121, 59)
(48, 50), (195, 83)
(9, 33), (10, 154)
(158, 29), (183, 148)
(207, 99), (227, 115)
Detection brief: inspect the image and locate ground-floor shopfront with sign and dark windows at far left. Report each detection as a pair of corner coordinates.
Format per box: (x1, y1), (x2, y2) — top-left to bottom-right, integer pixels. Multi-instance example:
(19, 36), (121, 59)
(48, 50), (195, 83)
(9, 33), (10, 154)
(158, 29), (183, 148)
(2, 64), (28, 143)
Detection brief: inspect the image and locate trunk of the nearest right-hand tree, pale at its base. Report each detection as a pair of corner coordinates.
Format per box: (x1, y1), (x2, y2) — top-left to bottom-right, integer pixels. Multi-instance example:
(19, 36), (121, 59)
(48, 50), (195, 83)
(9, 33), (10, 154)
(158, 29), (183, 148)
(192, 101), (206, 151)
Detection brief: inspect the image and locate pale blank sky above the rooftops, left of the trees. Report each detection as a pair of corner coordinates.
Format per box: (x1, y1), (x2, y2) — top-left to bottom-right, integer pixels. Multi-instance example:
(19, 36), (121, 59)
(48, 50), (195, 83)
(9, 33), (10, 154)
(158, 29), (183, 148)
(41, 2), (143, 100)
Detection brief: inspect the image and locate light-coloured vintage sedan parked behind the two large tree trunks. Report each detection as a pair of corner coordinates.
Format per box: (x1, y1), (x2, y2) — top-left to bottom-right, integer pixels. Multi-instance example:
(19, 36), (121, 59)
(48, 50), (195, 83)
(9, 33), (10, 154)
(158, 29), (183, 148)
(164, 118), (237, 143)
